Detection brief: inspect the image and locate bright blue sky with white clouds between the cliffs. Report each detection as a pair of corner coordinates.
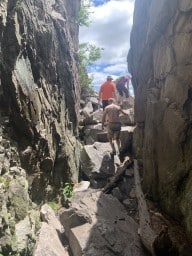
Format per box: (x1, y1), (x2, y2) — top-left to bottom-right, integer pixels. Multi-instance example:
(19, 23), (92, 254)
(79, 0), (134, 94)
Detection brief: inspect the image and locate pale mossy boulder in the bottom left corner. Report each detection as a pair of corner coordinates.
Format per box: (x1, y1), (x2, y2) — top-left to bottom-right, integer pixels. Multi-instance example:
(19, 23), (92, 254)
(0, 166), (40, 255)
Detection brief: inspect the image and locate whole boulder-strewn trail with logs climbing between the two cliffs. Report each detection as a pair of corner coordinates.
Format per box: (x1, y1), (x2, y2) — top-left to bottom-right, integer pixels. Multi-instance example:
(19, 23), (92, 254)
(34, 96), (191, 256)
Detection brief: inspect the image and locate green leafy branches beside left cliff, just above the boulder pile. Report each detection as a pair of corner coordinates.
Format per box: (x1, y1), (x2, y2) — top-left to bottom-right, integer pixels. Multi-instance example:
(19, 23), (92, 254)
(78, 43), (102, 92)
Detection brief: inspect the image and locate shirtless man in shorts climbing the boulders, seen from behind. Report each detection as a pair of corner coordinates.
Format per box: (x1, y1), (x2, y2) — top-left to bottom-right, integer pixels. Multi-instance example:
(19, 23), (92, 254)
(102, 98), (127, 155)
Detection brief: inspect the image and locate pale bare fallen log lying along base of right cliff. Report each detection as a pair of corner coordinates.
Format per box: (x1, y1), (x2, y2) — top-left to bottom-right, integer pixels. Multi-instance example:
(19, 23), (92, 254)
(134, 160), (157, 255)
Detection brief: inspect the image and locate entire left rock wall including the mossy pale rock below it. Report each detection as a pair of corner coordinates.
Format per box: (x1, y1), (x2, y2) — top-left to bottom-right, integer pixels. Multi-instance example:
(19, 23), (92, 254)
(0, 0), (80, 252)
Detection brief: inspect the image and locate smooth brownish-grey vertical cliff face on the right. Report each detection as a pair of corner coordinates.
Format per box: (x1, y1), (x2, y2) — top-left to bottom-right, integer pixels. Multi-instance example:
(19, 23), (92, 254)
(128, 0), (192, 236)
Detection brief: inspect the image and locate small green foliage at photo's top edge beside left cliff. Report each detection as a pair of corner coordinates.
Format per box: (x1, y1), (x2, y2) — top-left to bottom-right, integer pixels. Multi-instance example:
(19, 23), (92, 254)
(77, 0), (91, 27)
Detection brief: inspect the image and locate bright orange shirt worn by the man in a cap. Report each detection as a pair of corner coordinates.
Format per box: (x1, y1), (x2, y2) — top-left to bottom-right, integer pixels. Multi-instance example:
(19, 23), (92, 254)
(99, 81), (115, 100)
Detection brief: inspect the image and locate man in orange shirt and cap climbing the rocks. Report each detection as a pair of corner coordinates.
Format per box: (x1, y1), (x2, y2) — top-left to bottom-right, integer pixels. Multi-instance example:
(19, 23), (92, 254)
(99, 76), (116, 110)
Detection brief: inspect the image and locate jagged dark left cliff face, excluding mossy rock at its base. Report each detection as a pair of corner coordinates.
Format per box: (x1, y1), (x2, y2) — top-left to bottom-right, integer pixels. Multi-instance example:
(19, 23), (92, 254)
(0, 0), (80, 200)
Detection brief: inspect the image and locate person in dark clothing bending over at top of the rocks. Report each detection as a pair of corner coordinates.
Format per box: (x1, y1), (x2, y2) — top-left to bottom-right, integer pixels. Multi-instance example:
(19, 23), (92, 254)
(115, 76), (131, 104)
